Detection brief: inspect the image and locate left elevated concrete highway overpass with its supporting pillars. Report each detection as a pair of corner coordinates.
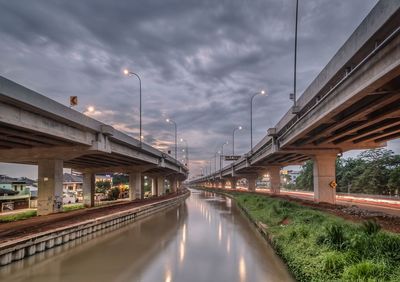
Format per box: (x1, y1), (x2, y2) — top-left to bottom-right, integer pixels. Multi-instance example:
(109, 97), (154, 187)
(0, 77), (188, 215)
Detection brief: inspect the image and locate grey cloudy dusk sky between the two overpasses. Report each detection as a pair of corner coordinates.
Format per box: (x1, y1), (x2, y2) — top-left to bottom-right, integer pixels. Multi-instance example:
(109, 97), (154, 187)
(0, 0), (396, 177)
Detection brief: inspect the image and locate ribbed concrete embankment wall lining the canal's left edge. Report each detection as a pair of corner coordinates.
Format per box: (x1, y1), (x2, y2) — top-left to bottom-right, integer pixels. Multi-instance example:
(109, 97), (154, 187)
(0, 191), (190, 266)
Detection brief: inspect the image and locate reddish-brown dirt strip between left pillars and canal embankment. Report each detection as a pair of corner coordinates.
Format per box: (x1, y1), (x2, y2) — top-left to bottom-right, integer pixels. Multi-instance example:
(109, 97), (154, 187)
(0, 194), (184, 244)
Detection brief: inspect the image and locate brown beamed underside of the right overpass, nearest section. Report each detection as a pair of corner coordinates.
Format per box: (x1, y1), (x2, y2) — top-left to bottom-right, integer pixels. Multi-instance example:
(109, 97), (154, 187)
(286, 74), (400, 150)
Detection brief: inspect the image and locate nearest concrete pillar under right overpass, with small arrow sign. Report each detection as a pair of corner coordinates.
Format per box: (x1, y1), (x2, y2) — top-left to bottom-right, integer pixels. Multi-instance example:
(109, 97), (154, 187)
(313, 153), (337, 204)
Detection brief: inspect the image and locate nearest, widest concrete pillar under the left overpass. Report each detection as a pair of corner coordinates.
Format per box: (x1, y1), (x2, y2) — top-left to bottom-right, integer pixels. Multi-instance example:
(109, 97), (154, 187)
(37, 160), (63, 215)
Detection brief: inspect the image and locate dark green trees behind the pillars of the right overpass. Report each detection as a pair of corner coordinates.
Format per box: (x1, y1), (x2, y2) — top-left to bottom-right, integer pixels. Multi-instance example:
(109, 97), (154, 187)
(285, 149), (400, 196)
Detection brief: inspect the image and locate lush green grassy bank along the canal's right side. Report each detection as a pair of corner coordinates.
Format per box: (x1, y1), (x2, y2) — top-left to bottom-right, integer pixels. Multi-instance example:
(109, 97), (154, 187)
(202, 187), (400, 281)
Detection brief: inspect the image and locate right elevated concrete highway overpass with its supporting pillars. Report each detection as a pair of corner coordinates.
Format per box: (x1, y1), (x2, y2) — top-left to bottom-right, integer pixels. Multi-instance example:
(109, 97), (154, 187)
(192, 0), (400, 203)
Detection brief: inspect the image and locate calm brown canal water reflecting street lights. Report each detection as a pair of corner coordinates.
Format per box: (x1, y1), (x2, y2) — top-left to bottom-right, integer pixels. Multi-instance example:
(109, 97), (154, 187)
(0, 190), (293, 282)
